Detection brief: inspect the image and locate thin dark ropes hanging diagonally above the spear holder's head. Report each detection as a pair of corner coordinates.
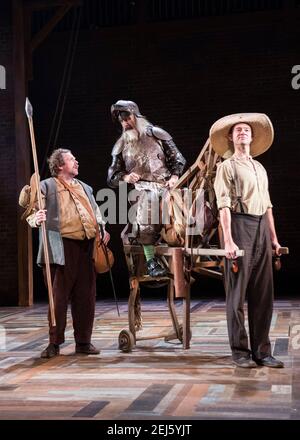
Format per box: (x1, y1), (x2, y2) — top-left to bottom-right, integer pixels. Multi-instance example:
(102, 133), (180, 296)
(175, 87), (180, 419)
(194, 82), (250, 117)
(41, 6), (82, 177)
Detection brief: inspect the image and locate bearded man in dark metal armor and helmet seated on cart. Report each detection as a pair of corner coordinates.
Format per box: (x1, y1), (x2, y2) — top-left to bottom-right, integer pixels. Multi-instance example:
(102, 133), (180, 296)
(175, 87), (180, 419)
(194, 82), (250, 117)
(107, 100), (186, 277)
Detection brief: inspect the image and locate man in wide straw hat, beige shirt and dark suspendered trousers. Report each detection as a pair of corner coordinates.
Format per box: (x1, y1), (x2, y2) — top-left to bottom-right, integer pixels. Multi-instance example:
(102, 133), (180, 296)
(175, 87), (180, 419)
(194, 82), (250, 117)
(210, 113), (284, 368)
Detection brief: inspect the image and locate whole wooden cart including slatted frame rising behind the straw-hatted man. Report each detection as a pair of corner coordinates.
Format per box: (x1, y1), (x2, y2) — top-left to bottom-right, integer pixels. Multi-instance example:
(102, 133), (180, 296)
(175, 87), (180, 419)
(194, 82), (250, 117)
(119, 140), (288, 352)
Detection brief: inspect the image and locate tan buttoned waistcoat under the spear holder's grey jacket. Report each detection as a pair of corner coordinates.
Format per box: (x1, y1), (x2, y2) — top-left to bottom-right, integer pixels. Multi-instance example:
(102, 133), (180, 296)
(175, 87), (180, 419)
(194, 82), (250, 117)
(26, 179), (104, 240)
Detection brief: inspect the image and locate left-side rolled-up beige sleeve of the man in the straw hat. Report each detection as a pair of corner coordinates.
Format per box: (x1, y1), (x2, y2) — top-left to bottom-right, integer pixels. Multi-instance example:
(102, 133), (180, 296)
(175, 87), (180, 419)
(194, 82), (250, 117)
(214, 162), (232, 209)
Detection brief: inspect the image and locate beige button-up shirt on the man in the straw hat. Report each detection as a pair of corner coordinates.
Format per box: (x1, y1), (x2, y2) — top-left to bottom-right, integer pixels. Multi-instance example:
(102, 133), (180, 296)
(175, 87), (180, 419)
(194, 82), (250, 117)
(214, 154), (273, 215)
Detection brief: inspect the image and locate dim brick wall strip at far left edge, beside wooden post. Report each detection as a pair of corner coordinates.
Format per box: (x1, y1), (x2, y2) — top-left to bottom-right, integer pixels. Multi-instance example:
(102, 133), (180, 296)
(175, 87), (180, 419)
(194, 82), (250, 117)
(0, 1), (18, 305)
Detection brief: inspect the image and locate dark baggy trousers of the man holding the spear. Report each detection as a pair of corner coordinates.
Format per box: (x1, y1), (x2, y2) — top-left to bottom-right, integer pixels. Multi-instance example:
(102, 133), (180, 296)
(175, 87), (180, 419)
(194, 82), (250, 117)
(43, 238), (96, 344)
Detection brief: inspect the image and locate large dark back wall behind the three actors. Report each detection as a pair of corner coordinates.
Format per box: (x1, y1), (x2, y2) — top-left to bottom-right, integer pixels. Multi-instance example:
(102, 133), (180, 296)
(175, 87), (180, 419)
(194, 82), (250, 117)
(14, 8), (300, 300)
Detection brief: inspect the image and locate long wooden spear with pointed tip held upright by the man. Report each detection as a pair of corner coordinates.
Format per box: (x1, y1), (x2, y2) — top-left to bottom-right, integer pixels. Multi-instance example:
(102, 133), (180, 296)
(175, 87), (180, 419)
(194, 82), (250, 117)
(25, 98), (56, 327)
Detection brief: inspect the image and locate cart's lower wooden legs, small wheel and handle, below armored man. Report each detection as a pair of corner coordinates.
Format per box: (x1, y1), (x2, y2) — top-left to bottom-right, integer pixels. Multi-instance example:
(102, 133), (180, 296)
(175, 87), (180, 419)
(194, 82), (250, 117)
(119, 245), (244, 352)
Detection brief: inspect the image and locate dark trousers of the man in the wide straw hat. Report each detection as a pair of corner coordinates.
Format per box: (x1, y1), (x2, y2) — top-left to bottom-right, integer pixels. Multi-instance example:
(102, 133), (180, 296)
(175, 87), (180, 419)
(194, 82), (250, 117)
(224, 214), (273, 359)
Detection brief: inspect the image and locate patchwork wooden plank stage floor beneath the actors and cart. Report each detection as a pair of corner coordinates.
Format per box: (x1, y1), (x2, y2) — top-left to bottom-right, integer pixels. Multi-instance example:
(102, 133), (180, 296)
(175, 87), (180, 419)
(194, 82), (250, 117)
(0, 299), (300, 420)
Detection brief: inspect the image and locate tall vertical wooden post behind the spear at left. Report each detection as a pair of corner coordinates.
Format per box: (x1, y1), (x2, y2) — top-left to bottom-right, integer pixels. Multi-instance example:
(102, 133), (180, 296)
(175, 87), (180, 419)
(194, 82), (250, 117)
(13, 0), (33, 306)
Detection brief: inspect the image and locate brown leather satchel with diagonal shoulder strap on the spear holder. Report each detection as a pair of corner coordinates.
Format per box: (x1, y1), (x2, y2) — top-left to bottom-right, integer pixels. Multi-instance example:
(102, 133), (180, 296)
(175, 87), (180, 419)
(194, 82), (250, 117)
(58, 179), (115, 273)
